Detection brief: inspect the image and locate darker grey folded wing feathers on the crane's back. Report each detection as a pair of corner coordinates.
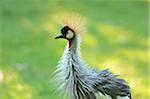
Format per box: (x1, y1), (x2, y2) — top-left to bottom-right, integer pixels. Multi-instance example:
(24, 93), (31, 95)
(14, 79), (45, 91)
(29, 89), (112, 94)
(94, 70), (131, 99)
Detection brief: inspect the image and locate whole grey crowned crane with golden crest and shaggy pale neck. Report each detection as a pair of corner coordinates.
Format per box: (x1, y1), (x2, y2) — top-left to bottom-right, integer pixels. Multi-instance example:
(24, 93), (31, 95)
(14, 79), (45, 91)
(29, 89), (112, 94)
(55, 16), (131, 99)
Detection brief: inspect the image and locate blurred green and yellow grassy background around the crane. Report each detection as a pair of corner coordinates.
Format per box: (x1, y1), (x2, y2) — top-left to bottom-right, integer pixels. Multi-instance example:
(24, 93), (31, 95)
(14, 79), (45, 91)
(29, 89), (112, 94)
(0, 0), (148, 99)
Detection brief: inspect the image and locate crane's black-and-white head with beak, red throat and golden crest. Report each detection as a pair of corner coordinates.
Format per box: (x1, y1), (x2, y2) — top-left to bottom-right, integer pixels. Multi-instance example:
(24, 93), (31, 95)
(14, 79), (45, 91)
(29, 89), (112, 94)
(55, 13), (86, 48)
